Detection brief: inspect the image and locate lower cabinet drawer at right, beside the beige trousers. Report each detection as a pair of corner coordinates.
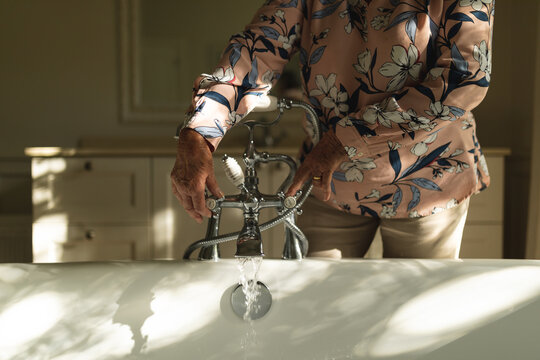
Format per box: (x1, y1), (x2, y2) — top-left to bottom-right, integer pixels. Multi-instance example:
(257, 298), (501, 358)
(459, 224), (503, 259)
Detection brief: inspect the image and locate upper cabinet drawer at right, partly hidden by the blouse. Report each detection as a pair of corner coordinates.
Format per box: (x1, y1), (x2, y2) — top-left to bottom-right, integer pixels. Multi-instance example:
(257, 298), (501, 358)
(467, 156), (504, 222)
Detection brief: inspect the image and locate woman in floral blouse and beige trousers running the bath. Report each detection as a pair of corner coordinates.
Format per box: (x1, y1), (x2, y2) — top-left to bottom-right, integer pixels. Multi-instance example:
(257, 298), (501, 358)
(171, 0), (494, 258)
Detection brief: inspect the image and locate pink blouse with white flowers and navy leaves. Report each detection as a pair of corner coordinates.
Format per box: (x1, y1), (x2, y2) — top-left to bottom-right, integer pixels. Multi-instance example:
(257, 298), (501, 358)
(187, 0), (494, 218)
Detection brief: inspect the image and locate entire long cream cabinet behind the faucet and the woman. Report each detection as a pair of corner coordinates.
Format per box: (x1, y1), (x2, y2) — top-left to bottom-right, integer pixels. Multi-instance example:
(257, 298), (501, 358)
(32, 151), (504, 262)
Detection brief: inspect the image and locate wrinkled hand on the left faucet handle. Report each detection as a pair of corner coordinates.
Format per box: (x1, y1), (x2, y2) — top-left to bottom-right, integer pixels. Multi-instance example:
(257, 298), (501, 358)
(171, 128), (224, 223)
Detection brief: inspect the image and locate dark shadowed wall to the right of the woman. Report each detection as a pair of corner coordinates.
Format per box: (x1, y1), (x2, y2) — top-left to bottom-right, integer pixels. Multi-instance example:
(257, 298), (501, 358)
(475, 0), (540, 258)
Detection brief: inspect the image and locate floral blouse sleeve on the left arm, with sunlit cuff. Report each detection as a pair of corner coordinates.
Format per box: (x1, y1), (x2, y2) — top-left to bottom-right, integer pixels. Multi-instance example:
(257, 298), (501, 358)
(186, 0), (303, 149)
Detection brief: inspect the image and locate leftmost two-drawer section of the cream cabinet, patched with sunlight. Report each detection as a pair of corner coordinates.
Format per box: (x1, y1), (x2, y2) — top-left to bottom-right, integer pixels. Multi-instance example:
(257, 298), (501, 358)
(32, 158), (152, 262)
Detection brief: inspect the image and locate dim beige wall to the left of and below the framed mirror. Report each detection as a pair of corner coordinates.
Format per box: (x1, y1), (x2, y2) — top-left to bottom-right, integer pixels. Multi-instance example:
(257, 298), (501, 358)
(0, 0), (180, 156)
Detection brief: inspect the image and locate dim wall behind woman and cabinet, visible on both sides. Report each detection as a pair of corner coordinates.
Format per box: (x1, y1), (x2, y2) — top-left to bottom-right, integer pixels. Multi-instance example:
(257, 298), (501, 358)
(0, 0), (540, 257)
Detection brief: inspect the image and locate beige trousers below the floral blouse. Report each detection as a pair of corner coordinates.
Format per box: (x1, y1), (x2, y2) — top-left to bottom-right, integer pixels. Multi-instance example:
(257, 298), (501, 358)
(297, 196), (469, 259)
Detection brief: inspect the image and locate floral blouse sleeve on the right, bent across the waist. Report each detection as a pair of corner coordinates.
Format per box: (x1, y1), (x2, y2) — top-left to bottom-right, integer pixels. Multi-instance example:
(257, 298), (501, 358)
(336, 0), (494, 152)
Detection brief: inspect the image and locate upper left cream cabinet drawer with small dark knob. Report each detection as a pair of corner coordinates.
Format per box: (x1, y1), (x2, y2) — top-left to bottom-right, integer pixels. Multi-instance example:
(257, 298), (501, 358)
(32, 158), (150, 223)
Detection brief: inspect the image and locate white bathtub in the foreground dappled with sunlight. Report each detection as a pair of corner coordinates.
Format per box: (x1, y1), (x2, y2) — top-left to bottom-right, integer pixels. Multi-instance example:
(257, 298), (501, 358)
(0, 259), (540, 360)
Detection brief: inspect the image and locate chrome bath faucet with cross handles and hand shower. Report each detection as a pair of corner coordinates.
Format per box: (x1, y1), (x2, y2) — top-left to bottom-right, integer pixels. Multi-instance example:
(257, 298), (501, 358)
(184, 97), (320, 260)
